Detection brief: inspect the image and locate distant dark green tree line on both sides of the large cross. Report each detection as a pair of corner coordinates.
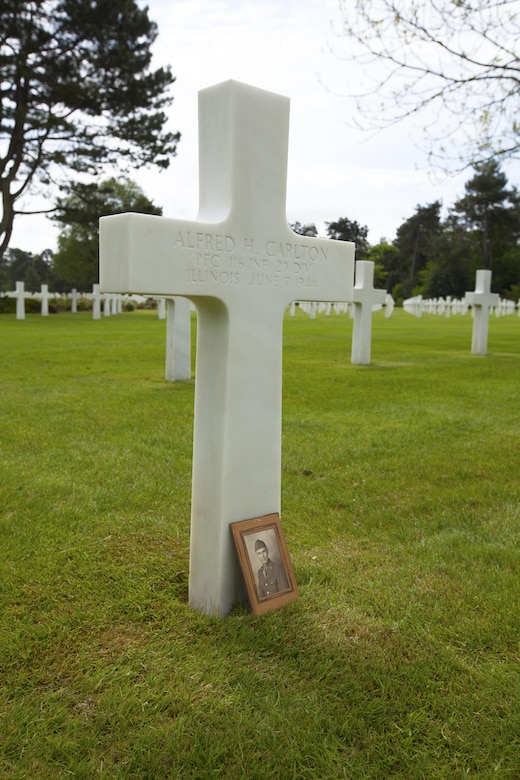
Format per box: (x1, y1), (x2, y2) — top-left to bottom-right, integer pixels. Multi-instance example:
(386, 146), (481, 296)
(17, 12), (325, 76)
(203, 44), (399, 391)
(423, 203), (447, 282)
(0, 162), (520, 303)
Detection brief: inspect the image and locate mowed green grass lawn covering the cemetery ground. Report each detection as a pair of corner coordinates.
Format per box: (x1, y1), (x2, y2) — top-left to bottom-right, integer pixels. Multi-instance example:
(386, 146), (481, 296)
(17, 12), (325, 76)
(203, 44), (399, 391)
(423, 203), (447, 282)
(0, 310), (520, 780)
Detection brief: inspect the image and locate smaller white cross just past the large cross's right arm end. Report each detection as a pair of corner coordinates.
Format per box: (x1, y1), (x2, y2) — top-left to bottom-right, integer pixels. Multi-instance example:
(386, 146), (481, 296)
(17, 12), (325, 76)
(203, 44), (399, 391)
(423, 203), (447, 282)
(351, 260), (386, 365)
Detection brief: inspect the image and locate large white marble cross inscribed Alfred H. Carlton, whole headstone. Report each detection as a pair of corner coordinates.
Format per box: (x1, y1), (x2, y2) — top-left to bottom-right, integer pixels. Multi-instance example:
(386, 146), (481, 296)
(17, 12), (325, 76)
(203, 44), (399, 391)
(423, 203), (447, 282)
(100, 81), (354, 616)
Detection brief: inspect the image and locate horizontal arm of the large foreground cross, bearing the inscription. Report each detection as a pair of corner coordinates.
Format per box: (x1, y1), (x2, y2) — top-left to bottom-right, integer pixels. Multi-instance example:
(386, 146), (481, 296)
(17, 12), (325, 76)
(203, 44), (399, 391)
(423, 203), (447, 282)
(100, 214), (354, 307)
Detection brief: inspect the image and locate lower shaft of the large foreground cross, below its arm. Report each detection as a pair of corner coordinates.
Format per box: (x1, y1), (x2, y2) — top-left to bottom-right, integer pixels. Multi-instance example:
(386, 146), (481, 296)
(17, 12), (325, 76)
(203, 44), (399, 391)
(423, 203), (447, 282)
(190, 300), (283, 616)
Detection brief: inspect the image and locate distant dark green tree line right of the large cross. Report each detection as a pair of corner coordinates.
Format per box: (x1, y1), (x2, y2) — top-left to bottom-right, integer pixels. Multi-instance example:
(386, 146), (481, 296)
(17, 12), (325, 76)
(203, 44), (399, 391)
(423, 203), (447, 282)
(292, 161), (520, 302)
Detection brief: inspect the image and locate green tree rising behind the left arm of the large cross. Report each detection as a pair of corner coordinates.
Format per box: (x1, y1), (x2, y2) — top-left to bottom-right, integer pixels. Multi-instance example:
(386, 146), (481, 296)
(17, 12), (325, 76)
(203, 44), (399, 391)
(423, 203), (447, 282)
(53, 179), (162, 290)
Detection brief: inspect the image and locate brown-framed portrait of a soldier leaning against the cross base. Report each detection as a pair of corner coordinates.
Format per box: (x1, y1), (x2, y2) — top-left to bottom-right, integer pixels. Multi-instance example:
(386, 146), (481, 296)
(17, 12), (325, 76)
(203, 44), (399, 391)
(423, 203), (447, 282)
(230, 514), (300, 614)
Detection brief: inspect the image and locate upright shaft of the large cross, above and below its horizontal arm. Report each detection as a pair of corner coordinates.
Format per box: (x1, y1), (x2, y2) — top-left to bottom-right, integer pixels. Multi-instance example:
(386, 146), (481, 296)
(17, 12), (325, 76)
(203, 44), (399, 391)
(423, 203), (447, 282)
(190, 83), (289, 615)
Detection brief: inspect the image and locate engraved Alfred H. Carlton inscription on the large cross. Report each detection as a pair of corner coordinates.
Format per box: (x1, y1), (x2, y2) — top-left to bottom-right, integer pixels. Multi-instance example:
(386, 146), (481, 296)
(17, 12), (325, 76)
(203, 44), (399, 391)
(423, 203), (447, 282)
(174, 230), (329, 289)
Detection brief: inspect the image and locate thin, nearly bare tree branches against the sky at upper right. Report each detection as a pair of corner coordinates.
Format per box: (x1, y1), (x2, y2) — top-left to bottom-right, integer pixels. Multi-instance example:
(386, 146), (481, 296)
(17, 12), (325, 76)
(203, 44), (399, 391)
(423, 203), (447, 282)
(341, 0), (520, 169)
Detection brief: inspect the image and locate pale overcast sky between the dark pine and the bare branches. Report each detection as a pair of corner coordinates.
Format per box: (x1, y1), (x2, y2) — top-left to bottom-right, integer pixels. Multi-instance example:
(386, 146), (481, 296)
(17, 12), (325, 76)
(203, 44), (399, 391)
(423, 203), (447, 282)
(11, 0), (515, 252)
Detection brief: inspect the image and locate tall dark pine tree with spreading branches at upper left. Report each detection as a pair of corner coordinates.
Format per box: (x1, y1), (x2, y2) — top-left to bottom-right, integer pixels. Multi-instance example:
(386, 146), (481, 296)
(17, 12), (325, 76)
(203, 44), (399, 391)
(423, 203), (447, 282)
(0, 0), (180, 260)
